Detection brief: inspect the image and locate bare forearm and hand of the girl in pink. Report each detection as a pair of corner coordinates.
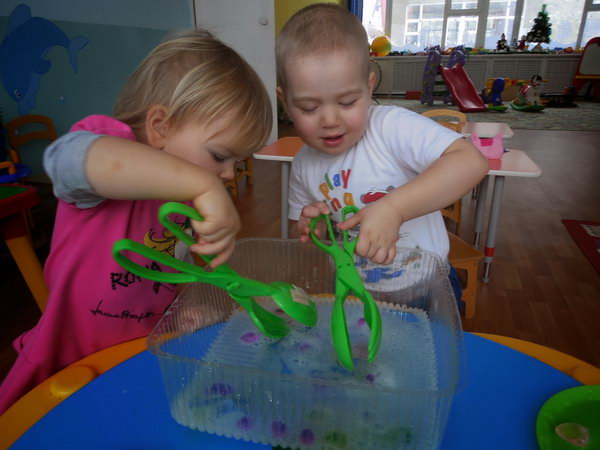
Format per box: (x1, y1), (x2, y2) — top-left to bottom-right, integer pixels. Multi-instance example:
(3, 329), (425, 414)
(85, 136), (241, 267)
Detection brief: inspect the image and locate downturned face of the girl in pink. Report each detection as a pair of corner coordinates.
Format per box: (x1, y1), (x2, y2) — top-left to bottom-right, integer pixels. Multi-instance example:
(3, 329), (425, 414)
(163, 112), (251, 180)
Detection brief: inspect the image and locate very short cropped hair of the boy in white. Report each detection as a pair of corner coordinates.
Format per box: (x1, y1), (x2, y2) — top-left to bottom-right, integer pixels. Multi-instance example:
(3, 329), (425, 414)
(276, 3), (370, 88)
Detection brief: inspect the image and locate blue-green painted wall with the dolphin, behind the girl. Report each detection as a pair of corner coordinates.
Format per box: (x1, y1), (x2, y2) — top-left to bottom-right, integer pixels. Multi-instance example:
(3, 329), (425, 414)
(0, 0), (194, 174)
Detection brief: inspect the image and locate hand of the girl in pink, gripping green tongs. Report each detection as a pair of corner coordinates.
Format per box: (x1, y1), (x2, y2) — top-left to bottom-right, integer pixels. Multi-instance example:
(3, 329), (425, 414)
(190, 188), (241, 267)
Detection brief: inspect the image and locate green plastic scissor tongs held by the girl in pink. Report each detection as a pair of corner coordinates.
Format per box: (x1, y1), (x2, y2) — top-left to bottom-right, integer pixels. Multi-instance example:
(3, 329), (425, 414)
(113, 202), (317, 338)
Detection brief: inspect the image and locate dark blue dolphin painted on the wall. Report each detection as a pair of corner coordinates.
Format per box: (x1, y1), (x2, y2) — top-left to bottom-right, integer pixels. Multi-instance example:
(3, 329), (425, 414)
(0, 5), (89, 115)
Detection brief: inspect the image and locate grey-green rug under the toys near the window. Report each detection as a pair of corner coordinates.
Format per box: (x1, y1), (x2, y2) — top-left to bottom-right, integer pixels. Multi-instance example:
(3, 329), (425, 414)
(375, 97), (600, 131)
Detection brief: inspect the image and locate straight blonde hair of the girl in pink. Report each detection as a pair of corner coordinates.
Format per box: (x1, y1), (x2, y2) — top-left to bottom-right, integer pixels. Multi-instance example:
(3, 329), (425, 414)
(115, 29), (273, 151)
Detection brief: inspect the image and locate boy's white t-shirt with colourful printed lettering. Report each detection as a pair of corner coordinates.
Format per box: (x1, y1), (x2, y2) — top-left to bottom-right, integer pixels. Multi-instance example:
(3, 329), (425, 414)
(289, 106), (461, 264)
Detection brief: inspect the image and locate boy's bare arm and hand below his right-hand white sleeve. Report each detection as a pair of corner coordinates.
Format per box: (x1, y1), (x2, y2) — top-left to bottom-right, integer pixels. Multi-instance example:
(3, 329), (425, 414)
(337, 139), (488, 264)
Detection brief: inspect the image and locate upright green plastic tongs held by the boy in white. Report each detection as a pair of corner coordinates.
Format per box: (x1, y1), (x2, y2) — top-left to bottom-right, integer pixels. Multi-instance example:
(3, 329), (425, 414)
(310, 206), (381, 370)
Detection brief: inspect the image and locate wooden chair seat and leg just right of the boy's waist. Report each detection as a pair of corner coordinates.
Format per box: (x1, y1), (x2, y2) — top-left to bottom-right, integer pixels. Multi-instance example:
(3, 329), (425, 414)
(442, 200), (484, 319)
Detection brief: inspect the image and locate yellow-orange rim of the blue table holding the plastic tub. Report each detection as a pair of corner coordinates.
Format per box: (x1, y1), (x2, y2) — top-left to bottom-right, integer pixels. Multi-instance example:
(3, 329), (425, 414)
(0, 333), (600, 448)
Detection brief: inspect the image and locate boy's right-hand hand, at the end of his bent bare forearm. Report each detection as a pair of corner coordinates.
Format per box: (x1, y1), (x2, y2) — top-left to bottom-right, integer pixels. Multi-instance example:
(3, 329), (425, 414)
(337, 198), (402, 264)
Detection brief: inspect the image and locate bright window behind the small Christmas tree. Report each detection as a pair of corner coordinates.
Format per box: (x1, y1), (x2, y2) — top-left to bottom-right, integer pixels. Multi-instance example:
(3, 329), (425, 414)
(370, 0), (600, 51)
